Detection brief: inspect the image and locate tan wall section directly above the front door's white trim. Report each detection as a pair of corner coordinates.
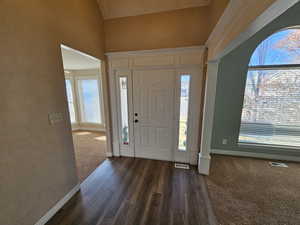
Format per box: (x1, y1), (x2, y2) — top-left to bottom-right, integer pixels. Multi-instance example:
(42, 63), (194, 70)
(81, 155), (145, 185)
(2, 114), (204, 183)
(104, 7), (210, 52)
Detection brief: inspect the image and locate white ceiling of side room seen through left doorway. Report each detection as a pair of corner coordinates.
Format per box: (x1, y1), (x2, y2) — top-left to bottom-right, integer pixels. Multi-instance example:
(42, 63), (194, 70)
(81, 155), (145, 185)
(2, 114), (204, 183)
(61, 46), (100, 70)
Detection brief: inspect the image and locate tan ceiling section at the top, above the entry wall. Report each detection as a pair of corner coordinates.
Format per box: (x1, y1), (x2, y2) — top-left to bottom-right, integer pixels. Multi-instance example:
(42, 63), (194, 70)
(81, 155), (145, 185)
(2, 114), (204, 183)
(98, 0), (211, 19)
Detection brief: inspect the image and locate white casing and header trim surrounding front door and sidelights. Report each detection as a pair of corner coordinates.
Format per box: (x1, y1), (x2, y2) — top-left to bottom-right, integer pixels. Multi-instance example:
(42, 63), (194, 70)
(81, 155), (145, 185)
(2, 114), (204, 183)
(106, 46), (205, 165)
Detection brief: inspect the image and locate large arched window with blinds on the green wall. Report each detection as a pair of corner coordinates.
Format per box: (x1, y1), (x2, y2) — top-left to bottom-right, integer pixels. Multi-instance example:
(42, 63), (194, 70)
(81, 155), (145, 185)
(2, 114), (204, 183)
(239, 28), (300, 147)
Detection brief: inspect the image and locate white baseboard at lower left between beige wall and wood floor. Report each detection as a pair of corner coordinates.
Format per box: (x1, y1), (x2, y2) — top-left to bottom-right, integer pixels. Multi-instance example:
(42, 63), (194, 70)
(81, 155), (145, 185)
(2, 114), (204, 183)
(35, 184), (80, 225)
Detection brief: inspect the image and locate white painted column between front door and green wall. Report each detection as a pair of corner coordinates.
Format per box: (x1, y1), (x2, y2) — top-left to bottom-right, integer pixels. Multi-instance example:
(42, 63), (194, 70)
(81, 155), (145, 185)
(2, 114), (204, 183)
(198, 61), (219, 175)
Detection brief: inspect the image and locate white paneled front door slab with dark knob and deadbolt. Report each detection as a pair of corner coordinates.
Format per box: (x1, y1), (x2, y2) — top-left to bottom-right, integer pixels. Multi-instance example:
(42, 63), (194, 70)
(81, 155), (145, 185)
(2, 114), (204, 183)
(133, 70), (176, 160)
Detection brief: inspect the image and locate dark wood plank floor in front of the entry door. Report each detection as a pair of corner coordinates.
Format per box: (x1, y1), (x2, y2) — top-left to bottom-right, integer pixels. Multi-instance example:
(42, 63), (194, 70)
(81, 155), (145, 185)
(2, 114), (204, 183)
(47, 158), (216, 225)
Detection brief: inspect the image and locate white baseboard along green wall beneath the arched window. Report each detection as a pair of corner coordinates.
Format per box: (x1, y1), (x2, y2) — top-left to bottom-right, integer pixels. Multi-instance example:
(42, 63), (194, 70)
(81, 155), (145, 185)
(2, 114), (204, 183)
(211, 149), (300, 162)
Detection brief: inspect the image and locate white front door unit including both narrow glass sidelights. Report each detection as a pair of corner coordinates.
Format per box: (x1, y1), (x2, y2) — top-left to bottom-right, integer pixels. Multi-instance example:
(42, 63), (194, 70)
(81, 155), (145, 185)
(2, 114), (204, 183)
(115, 68), (202, 164)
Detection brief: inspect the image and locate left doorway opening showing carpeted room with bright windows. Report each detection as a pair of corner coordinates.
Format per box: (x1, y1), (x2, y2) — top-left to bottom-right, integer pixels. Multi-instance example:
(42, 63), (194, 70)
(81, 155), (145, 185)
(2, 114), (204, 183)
(61, 45), (107, 182)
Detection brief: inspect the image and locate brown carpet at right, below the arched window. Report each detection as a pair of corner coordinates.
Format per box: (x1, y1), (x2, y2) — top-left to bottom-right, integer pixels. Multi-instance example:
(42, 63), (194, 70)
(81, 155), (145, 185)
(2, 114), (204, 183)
(206, 156), (300, 225)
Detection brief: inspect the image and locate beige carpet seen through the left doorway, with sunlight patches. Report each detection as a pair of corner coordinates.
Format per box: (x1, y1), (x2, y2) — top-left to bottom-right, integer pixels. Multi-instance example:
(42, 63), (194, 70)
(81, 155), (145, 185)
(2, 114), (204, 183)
(73, 131), (106, 182)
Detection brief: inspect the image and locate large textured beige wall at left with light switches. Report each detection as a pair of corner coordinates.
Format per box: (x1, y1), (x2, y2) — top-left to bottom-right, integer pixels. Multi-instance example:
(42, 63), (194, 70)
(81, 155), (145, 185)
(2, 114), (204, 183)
(0, 0), (104, 225)
